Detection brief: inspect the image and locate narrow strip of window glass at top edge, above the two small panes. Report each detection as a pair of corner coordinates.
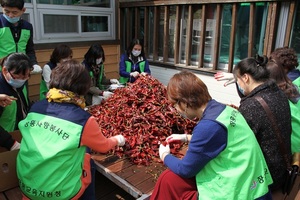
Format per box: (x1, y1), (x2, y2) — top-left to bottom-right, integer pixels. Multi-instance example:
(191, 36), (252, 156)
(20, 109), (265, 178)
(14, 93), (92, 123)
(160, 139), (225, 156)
(37, 0), (111, 8)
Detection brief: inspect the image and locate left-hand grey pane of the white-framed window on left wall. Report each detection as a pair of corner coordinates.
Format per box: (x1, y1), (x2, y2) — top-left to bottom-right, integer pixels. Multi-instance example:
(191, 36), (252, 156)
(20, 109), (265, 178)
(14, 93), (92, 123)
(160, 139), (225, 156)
(43, 14), (79, 34)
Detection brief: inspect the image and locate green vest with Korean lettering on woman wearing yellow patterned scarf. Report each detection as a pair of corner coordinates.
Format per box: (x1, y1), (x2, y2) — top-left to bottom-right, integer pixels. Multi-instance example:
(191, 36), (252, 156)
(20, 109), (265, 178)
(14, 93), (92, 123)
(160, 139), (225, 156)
(17, 112), (86, 199)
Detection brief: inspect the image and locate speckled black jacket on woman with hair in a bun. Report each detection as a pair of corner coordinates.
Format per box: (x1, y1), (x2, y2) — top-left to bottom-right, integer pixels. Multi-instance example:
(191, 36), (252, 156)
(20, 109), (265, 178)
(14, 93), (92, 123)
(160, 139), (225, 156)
(239, 81), (292, 190)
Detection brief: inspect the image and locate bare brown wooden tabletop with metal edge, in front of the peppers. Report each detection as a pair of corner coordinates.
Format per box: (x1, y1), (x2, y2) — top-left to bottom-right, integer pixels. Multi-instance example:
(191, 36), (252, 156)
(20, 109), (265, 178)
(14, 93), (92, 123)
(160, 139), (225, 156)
(94, 146), (187, 200)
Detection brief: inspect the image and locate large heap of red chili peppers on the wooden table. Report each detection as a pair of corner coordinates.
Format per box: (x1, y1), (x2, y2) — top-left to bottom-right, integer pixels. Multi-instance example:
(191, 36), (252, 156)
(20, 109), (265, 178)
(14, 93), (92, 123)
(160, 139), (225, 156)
(88, 75), (196, 165)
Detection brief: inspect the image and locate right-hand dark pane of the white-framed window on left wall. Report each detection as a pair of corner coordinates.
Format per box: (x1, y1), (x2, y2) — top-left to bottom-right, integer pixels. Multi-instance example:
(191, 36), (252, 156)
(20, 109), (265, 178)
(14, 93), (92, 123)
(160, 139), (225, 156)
(81, 16), (108, 32)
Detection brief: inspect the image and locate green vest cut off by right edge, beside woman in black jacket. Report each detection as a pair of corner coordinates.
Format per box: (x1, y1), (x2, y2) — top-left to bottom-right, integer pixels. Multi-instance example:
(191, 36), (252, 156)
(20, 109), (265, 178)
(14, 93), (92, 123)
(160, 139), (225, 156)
(289, 101), (300, 153)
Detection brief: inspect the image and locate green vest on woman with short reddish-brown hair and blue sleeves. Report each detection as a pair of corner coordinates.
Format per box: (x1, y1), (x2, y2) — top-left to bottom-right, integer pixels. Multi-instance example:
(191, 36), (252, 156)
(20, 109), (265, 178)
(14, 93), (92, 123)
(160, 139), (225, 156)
(196, 106), (273, 200)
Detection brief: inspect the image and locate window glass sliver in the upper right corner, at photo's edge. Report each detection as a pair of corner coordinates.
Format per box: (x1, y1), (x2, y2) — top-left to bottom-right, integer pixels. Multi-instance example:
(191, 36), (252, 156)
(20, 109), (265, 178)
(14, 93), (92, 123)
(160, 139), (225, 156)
(290, 3), (300, 69)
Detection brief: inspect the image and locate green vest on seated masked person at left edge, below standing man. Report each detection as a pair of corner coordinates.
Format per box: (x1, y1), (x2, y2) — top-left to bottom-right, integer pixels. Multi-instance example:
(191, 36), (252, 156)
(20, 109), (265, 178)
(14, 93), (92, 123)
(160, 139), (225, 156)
(0, 86), (29, 132)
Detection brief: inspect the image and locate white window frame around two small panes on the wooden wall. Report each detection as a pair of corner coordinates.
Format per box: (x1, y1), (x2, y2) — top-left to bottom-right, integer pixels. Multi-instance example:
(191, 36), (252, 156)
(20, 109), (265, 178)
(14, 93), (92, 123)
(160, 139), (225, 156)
(16, 0), (117, 44)
